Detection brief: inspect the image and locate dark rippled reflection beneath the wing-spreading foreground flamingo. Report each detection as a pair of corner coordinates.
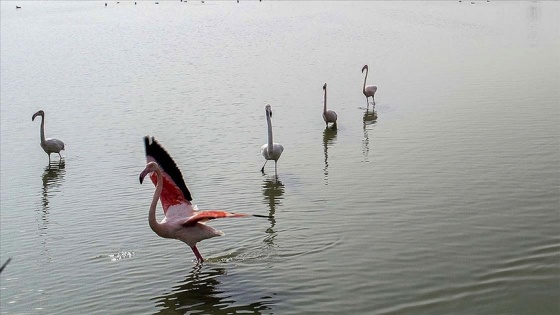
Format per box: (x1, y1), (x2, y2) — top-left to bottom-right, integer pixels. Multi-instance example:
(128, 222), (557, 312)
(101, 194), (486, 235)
(152, 265), (273, 314)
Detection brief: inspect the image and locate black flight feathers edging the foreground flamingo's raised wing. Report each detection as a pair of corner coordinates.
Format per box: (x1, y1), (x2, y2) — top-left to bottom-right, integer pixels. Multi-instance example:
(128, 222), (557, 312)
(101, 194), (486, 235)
(144, 136), (192, 201)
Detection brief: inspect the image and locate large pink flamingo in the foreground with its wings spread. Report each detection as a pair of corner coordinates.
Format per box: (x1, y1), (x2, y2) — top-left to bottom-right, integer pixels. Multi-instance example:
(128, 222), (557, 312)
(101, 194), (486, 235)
(140, 137), (254, 262)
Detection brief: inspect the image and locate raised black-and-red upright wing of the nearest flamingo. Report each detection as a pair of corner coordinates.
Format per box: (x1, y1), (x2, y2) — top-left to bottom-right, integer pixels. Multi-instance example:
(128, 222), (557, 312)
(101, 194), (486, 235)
(144, 137), (192, 214)
